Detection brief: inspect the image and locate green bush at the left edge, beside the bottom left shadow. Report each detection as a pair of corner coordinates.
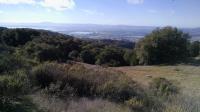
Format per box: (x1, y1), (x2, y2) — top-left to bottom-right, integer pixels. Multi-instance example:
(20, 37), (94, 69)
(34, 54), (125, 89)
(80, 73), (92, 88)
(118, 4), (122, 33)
(0, 70), (30, 112)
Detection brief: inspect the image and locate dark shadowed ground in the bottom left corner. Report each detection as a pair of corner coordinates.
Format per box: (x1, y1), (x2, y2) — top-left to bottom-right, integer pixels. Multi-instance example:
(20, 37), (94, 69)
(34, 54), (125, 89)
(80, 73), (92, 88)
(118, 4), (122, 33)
(0, 97), (44, 112)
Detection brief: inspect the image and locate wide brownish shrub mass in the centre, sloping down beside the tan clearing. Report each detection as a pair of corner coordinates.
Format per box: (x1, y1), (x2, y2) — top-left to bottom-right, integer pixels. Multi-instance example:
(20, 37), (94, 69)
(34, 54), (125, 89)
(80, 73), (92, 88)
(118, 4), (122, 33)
(65, 65), (141, 102)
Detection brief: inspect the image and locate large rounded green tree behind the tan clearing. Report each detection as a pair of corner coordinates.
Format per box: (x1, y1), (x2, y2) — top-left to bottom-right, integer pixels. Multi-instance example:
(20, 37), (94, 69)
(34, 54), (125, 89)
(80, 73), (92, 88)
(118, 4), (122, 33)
(135, 27), (190, 64)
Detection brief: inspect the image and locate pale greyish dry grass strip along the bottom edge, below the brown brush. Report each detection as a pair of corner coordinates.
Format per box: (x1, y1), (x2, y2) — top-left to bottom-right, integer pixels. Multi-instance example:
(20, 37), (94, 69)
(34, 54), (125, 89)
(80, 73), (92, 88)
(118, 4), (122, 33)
(31, 93), (133, 112)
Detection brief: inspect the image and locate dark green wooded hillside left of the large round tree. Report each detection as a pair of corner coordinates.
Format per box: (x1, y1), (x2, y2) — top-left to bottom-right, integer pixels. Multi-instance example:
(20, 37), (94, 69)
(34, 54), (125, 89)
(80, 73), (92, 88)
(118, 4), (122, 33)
(0, 28), (134, 66)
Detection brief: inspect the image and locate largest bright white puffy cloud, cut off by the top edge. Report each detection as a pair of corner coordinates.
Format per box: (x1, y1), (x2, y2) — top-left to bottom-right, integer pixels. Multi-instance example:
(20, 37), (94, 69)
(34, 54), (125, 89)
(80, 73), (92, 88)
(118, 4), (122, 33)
(40, 0), (75, 11)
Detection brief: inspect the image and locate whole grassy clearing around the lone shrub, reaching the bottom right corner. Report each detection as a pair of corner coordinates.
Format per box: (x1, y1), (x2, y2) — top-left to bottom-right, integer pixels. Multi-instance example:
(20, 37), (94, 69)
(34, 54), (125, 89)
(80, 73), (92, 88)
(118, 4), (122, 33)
(112, 65), (200, 112)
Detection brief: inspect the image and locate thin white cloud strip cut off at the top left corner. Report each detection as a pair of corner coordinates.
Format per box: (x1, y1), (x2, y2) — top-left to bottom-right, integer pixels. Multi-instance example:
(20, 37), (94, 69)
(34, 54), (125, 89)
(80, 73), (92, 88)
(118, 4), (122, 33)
(0, 0), (35, 4)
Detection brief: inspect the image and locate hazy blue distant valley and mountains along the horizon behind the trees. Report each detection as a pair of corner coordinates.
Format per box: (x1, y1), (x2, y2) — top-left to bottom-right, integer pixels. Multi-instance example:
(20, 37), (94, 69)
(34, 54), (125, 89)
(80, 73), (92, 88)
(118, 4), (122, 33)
(0, 23), (200, 41)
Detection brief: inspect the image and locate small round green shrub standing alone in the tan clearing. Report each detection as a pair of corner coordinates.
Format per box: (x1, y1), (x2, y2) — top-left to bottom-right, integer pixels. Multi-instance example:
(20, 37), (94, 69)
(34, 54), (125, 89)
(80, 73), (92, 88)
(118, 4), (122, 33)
(150, 78), (178, 96)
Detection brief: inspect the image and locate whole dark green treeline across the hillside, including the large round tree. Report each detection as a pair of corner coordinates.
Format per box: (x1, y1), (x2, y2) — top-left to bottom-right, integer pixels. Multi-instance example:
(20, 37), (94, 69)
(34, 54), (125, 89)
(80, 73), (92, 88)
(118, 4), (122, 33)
(0, 27), (200, 66)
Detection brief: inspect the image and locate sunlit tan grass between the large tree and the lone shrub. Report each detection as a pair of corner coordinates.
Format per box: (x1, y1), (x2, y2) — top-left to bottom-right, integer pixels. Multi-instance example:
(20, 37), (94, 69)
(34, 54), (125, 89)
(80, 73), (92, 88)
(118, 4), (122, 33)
(112, 65), (200, 99)
